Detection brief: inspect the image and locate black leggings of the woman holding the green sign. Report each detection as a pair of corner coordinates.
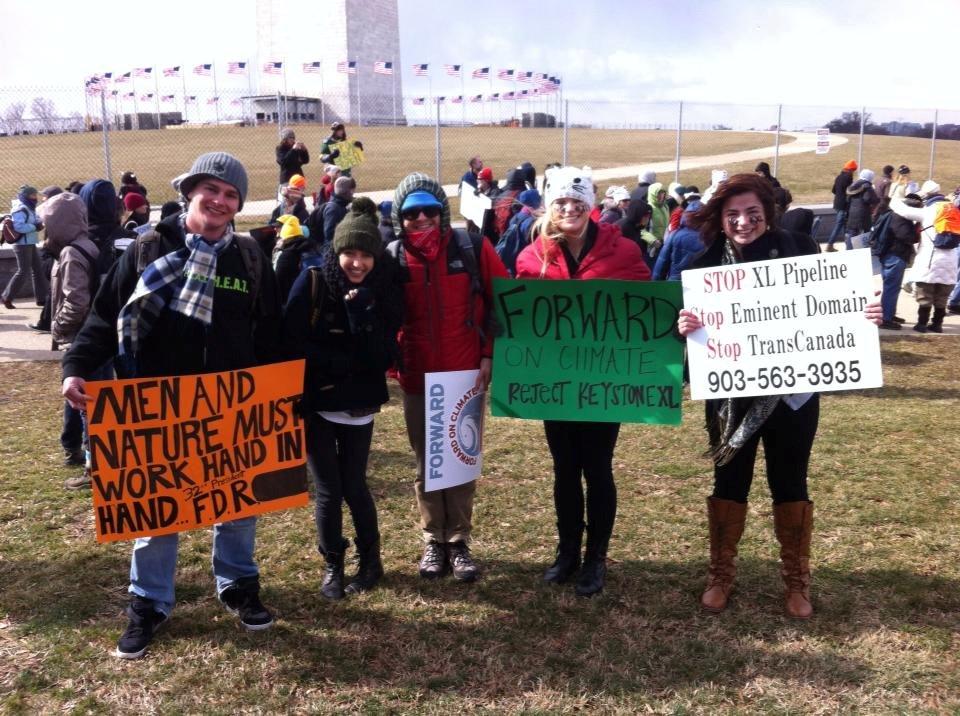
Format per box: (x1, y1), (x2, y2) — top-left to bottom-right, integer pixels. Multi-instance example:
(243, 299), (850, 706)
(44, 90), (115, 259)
(543, 420), (620, 554)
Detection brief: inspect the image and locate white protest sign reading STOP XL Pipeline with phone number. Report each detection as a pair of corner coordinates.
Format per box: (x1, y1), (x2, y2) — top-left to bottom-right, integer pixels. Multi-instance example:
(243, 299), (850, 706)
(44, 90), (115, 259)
(681, 249), (883, 400)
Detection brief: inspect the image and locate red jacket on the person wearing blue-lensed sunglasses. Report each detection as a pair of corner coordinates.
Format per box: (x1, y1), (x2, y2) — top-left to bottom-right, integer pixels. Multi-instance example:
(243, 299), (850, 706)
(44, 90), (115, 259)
(398, 231), (507, 393)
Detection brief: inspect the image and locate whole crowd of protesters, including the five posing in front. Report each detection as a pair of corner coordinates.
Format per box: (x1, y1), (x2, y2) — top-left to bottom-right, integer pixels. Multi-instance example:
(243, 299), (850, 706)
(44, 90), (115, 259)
(3, 131), (957, 659)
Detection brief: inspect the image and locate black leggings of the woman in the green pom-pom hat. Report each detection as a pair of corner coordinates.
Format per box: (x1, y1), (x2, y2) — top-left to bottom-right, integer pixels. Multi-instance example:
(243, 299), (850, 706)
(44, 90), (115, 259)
(307, 415), (380, 554)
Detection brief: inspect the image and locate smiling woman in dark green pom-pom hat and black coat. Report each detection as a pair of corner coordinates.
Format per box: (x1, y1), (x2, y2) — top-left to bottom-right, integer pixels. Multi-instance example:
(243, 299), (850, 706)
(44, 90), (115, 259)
(283, 197), (403, 600)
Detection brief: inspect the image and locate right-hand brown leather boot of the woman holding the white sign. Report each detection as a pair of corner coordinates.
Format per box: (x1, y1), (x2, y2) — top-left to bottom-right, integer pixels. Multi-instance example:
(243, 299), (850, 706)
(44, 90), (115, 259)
(773, 501), (813, 619)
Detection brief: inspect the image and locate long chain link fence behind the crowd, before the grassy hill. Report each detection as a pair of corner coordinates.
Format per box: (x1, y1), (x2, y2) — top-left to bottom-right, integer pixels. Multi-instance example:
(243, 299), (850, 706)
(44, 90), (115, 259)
(0, 81), (960, 214)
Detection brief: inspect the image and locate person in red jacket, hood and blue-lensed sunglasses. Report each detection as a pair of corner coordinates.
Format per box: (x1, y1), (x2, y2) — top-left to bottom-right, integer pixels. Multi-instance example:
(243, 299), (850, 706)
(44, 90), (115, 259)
(387, 173), (507, 582)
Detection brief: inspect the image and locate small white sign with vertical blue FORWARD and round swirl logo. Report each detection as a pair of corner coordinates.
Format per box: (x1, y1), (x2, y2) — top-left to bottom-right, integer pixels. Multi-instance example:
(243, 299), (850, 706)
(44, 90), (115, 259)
(423, 370), (485, 492)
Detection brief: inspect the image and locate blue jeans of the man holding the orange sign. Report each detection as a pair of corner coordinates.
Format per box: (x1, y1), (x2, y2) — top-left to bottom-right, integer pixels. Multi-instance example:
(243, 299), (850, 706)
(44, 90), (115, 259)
(127, 517), (259, 616)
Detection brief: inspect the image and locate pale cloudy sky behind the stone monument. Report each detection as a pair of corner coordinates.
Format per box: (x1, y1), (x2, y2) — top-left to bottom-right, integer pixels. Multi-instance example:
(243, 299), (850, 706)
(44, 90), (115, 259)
(0, 0), (960, 121)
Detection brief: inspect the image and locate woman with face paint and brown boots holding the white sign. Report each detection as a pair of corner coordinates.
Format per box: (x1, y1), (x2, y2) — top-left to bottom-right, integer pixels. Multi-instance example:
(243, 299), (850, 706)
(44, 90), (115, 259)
(677, 174), (882, 619)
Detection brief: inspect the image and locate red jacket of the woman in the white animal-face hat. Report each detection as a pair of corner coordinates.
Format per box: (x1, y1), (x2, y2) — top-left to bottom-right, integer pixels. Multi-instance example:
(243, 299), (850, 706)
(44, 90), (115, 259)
(517, 224), (650, 281)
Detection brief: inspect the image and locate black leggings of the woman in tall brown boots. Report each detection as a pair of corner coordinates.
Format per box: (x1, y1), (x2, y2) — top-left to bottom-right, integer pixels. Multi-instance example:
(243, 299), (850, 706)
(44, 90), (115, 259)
(713, 394), (820, 505)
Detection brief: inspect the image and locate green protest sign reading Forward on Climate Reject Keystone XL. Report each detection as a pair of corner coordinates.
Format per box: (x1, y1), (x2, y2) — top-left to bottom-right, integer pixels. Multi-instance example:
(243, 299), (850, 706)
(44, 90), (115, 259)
(491, 279), (683, 425)
